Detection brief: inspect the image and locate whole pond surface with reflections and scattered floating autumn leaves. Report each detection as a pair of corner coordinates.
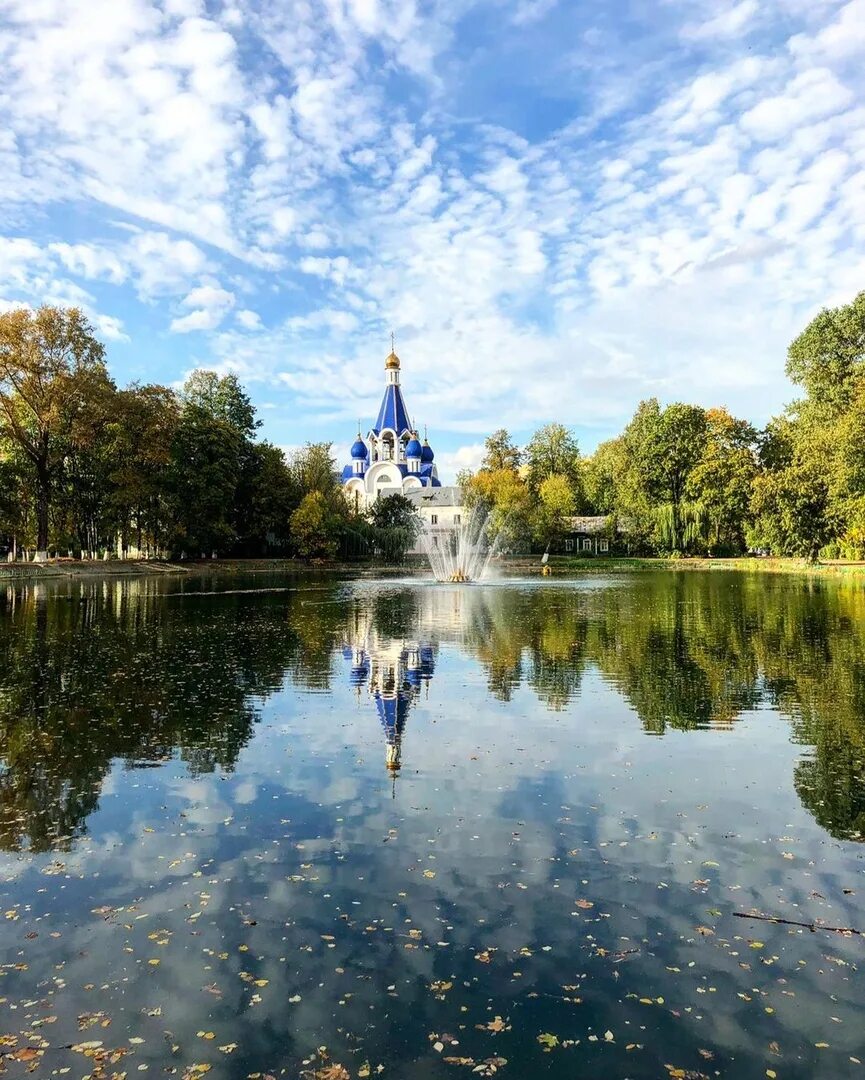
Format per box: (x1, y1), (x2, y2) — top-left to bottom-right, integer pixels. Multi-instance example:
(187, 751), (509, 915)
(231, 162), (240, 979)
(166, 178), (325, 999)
(0, 571), (865, 1080)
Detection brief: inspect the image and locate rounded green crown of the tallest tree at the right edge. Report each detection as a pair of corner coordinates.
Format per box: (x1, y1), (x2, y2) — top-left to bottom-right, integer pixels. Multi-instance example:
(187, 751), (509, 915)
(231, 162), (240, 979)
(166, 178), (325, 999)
(787, 292), (865, 409)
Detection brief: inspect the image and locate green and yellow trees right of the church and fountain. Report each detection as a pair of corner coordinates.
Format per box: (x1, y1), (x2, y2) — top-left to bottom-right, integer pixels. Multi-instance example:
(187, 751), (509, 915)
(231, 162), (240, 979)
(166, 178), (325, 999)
(460, 293), (865, 559)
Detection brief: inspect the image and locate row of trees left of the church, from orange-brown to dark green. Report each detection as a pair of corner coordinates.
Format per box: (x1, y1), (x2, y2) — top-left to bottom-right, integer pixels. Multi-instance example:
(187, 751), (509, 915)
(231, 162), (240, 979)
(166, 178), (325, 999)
(0, 307), (418, 558)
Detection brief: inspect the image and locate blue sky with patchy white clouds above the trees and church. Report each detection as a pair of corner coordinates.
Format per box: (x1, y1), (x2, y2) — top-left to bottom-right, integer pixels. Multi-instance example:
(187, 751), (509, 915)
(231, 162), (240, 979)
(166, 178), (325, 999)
(0, 0), (865, 480)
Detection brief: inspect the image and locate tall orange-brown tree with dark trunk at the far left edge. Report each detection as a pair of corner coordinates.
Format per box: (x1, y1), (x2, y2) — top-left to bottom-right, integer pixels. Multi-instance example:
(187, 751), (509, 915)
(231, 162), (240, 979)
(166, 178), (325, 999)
(0, 306), (109, 556)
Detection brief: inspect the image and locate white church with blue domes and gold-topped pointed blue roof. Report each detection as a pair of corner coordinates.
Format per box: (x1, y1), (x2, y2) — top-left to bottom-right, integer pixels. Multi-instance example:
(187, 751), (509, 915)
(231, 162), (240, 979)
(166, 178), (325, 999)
(342, 349), (442, 516)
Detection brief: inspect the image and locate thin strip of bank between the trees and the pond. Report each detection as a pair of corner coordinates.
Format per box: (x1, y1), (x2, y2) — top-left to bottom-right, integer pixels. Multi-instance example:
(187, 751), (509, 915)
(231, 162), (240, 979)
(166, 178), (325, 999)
(0, 555), (865, 583)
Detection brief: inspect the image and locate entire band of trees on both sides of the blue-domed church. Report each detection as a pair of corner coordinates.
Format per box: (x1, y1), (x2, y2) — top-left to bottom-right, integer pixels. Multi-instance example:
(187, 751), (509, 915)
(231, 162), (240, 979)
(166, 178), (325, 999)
(0, 293), (865, 559)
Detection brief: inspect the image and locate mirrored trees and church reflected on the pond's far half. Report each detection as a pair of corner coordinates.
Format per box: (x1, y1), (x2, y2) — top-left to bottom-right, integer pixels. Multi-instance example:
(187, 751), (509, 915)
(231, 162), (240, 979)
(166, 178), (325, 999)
(0, 572), (865, 851)
